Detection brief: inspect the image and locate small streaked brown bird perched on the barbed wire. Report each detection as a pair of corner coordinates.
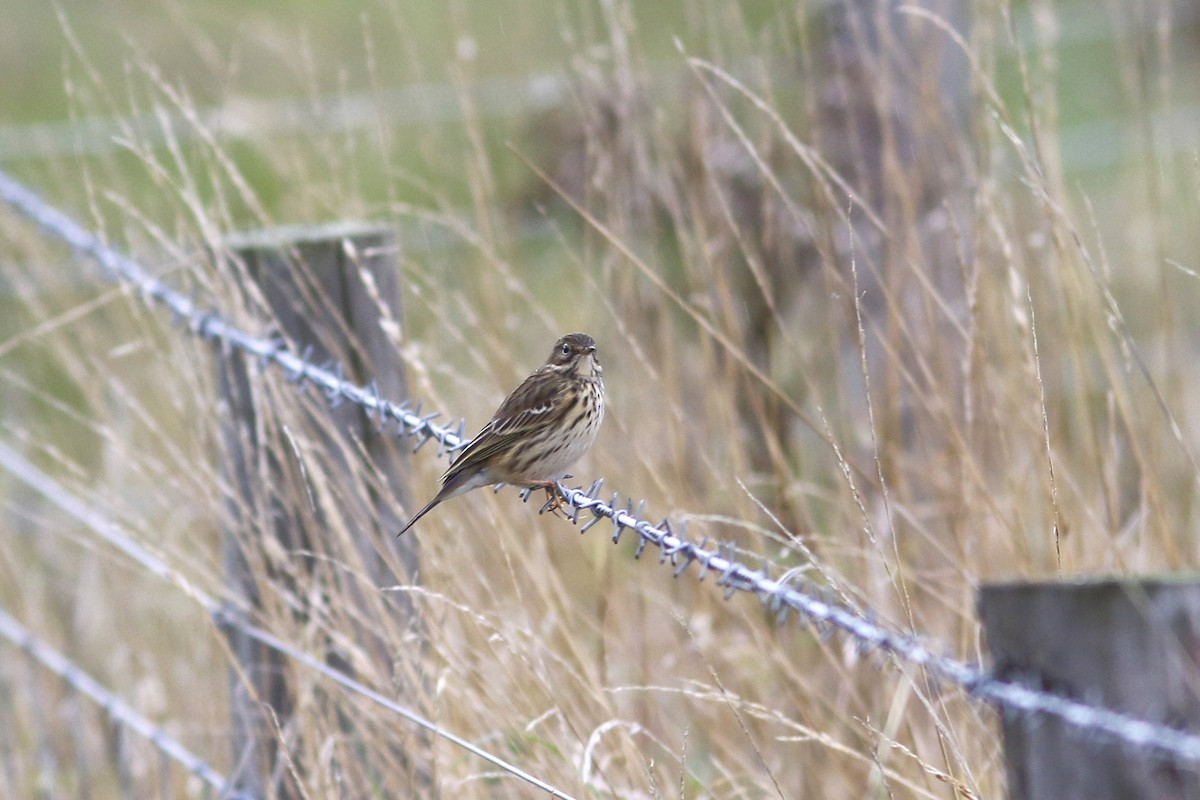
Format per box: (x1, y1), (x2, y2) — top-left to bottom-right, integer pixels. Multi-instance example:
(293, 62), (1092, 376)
(396, 333), (604, 536)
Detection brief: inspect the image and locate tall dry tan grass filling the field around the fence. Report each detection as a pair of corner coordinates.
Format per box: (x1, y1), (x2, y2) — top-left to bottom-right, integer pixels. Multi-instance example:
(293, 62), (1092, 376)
(0, 0), (1200, 798)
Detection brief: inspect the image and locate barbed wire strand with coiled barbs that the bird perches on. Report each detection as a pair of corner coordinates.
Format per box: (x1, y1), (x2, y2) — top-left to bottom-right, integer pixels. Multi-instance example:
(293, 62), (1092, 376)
(0, 172), (1200, 777)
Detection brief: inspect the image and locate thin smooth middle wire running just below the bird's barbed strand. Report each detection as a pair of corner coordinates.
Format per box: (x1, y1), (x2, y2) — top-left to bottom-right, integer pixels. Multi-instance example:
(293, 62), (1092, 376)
(0, 441), (575, 800)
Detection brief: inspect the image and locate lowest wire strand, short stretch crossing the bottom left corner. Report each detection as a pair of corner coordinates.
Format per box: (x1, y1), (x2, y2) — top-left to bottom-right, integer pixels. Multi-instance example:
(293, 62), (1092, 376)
(0, 608), (251, 800)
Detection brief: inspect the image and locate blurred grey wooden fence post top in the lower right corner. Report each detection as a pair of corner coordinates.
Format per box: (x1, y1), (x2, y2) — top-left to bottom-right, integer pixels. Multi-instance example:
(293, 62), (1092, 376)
(979, 581), (1200, 800)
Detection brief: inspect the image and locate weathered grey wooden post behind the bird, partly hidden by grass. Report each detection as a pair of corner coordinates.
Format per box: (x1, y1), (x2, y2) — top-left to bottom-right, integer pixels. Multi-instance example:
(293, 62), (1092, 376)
(217, 225), (418, 798)
